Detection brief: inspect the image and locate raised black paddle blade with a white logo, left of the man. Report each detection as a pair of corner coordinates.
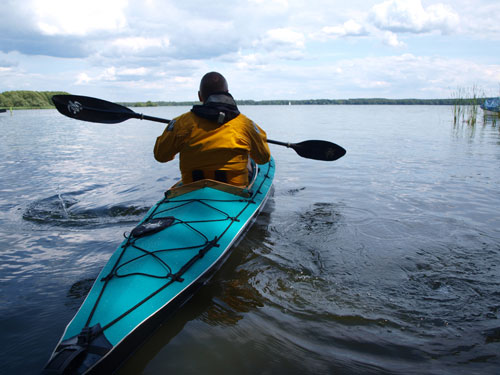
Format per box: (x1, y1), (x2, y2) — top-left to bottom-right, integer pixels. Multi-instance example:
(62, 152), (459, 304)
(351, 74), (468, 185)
(52, 95), (138, 124)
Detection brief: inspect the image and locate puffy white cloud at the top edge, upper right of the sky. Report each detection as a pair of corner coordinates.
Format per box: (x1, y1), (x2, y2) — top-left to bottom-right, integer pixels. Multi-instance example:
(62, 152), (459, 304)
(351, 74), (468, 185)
(370, 0), (459, 33)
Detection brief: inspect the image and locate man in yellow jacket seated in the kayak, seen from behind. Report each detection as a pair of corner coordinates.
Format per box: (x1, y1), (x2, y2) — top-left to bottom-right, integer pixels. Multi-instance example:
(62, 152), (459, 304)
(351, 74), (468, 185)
(154, 72), (271, 186)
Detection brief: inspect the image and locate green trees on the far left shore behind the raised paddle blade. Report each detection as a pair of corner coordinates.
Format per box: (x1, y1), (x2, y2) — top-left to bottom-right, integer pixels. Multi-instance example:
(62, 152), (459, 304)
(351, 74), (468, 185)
(0, 91), (67, 109)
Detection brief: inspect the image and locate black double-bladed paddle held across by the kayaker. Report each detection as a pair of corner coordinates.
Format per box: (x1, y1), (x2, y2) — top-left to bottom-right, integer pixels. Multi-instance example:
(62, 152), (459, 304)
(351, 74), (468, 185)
(52, 95), (346, 161)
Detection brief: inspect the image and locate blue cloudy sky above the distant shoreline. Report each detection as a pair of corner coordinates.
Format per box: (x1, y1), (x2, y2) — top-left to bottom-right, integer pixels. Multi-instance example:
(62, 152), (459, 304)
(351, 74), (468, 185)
(0, 0), (500, 101)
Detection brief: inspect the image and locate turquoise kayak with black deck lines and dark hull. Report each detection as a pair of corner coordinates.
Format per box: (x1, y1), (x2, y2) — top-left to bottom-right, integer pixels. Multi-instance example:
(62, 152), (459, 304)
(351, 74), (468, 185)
(42, 158), (275, 374)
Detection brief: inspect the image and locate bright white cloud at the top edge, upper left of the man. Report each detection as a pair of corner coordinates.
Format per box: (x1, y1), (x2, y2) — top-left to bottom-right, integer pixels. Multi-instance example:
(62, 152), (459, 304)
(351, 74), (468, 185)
(31, 0), (128, 36)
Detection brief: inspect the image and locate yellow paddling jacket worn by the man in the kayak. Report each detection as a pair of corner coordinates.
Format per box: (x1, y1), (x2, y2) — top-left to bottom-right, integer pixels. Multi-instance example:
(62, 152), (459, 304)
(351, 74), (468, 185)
(154, 112), (271, 186)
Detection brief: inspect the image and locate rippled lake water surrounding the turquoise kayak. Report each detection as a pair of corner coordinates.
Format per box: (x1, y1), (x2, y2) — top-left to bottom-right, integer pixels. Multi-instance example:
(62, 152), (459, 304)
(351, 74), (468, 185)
(0, 106), (500, 375)
